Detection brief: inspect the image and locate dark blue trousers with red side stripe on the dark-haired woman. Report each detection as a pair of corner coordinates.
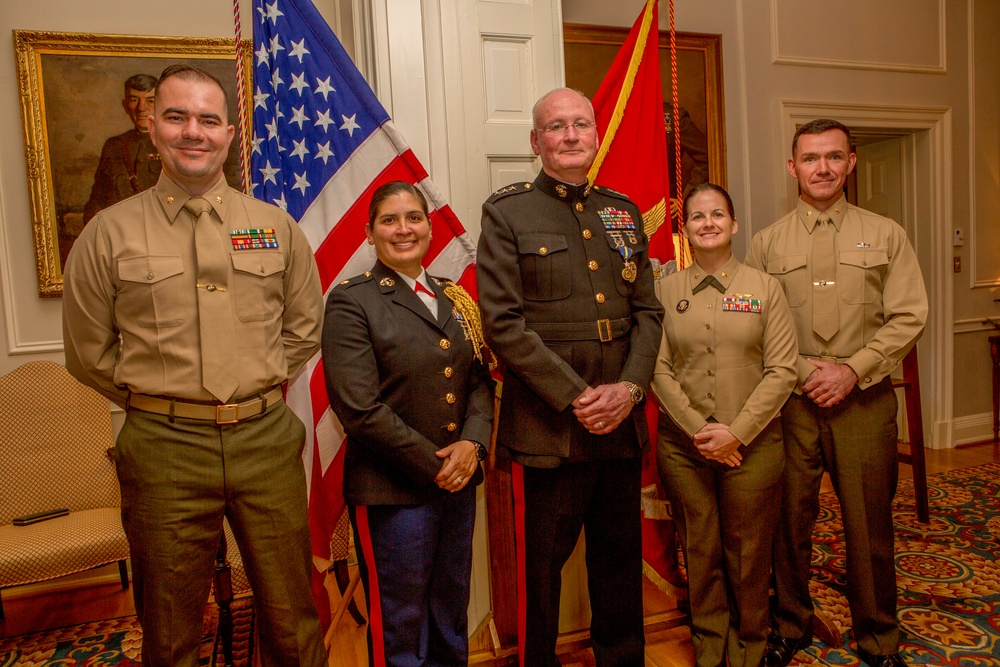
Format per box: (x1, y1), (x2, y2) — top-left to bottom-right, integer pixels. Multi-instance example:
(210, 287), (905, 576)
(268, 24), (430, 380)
(348, 486), (476, 667)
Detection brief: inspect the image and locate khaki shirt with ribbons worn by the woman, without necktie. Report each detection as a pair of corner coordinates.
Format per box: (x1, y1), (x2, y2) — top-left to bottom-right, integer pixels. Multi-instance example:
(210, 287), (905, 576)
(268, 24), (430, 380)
(651, 257), (798, 445)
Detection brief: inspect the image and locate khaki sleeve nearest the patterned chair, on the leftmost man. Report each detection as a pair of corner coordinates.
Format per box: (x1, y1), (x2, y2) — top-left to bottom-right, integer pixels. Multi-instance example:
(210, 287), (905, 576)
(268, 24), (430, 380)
(63, 216), (128, 407)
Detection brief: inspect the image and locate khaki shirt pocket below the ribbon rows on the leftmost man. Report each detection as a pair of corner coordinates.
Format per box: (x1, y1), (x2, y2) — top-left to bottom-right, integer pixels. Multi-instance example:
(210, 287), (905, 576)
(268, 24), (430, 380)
(230, 250), (285, 322)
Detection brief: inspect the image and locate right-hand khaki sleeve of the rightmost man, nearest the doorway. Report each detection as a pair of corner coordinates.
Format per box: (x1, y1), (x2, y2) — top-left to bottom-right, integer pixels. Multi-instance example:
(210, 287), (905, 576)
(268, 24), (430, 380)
(846, 223), (928, 389)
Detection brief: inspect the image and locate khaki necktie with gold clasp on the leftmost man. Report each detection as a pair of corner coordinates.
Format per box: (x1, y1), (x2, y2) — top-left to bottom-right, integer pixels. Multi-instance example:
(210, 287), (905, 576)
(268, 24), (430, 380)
(184, 197), (240, 403)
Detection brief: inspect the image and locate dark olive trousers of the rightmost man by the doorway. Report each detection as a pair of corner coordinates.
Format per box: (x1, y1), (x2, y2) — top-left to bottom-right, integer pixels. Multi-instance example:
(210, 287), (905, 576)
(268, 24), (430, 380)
(774, 378), (899, 655)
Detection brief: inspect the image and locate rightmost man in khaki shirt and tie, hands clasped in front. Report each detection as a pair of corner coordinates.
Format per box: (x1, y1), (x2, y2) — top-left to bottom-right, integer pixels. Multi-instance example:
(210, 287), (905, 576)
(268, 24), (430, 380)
(747, 119), (927, 667)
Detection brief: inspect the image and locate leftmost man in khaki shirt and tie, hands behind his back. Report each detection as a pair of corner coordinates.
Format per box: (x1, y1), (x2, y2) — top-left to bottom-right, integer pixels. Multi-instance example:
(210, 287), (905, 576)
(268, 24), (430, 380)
(63, 65), (326, 667)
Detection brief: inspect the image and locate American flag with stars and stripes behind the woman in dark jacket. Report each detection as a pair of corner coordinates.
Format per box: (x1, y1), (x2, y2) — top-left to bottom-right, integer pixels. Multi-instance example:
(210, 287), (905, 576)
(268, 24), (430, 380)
(250, 0), (475, 627)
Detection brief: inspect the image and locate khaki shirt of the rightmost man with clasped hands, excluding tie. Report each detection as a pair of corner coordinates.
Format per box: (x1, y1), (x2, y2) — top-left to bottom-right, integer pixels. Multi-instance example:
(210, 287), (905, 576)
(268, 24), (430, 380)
(747, 198), (927, 389)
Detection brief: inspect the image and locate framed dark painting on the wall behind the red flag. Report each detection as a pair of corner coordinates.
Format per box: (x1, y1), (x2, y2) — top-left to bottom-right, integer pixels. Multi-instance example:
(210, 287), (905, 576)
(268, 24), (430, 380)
(563, 23), (726, 205)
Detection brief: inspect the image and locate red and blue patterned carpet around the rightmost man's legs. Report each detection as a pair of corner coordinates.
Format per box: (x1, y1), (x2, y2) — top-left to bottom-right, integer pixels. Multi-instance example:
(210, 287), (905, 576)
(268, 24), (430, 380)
(792, 463), (1000, 667)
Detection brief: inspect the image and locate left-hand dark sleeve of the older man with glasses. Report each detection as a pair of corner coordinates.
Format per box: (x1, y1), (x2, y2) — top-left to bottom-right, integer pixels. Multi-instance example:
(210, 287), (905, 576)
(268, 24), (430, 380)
(476, 202), (584, 412)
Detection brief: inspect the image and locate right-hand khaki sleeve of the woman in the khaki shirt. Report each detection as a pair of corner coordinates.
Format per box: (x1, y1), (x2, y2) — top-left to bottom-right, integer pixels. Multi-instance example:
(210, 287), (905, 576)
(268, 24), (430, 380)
(729, 276), (799, 445)
